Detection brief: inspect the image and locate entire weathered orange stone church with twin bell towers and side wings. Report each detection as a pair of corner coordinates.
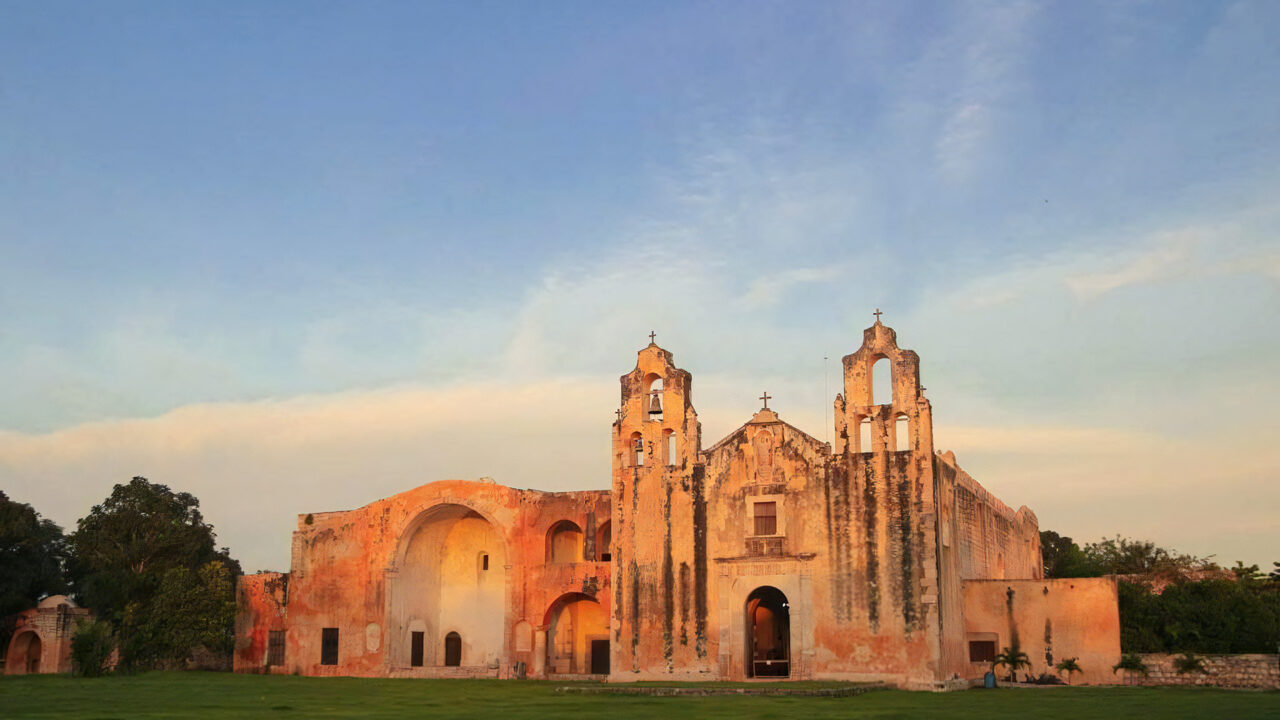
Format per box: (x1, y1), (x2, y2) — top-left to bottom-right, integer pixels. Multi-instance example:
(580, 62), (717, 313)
(234, 320), (1120, 689)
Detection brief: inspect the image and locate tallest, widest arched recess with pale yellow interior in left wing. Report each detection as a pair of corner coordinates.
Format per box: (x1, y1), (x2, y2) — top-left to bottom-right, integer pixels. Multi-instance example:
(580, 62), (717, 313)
(388, 502), (507, 667)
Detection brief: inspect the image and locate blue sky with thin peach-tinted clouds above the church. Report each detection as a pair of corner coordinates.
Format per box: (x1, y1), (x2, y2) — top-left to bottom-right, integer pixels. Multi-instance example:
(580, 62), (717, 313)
(0, 1), (1280, 568)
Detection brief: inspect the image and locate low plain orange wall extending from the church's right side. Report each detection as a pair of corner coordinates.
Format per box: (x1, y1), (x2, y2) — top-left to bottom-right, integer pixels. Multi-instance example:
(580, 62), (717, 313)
(961, 578), (1120, 684)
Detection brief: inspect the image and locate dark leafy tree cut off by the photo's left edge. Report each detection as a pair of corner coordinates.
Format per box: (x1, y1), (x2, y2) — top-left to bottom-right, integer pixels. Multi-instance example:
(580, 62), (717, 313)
(0, 491), (67, 648)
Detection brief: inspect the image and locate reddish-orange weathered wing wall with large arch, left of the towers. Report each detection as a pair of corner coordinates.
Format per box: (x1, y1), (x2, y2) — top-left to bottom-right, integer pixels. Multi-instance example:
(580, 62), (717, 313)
(236, 480), (611, 676)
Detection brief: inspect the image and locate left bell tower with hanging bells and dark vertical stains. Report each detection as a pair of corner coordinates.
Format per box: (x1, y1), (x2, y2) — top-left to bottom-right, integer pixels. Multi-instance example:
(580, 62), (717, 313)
(609, 333), (714, 680)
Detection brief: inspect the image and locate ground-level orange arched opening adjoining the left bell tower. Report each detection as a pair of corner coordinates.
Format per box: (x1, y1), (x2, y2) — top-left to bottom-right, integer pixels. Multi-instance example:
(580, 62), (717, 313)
(543, 593), (609, 675)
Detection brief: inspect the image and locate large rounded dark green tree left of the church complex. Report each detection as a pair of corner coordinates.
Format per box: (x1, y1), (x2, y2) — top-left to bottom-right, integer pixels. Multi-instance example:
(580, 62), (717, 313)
(69, 478), (239, 669)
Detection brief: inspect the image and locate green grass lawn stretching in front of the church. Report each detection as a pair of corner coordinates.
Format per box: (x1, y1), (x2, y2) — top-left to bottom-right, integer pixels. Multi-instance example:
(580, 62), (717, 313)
(0, 673), (1280, 720)
